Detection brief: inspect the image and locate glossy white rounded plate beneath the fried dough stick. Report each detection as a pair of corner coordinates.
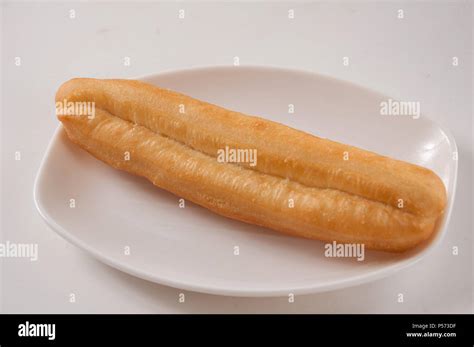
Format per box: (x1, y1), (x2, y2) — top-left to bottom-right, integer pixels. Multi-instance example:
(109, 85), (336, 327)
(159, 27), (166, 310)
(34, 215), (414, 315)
(35, 67), (457, 296)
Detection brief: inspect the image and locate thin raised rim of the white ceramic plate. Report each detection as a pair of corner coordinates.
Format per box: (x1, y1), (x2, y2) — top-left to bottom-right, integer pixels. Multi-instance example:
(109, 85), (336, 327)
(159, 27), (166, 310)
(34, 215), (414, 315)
(33, 65), (459, 297)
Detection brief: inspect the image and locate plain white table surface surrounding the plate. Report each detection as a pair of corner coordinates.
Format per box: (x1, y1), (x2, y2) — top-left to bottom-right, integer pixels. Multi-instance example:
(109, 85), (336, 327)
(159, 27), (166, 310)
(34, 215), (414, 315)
(0, 1), (473, 313)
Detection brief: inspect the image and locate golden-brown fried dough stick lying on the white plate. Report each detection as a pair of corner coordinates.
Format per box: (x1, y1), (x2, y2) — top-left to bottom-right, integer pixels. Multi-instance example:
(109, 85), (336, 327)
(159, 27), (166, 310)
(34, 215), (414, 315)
(56, 78), (446, 252)
